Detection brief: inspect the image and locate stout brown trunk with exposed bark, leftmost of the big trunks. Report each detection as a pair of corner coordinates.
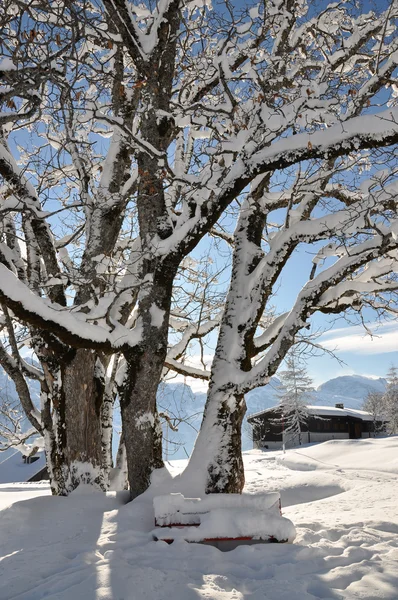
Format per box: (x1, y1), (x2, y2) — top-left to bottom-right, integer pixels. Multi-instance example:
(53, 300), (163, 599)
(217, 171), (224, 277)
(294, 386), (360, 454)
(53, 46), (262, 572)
(35, 337), (109, 496)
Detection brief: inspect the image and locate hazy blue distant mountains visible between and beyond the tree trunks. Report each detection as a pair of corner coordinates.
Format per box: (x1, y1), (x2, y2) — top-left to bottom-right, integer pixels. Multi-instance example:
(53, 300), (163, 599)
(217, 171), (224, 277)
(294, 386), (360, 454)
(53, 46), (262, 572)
(0, 368), (387, 460)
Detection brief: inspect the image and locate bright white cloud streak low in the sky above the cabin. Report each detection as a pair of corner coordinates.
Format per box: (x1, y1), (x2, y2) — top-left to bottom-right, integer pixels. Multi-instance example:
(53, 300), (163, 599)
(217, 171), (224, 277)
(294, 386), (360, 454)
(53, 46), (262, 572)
(320, 323), (398, 354)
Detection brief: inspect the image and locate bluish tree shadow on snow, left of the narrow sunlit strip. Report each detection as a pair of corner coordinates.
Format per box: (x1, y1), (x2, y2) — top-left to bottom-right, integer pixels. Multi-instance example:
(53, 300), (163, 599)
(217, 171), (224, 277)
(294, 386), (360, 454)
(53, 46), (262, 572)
(0, 486), (117, 600)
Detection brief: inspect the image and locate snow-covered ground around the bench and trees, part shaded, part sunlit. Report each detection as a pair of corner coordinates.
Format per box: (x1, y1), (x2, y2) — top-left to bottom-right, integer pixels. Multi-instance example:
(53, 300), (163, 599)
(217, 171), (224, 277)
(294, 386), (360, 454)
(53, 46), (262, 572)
(0, 437), (398, 600)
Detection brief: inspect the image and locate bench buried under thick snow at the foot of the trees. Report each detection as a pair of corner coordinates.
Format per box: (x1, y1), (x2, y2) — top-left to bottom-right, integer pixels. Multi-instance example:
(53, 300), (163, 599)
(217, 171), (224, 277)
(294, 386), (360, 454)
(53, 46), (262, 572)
(152, 492), (296, 550)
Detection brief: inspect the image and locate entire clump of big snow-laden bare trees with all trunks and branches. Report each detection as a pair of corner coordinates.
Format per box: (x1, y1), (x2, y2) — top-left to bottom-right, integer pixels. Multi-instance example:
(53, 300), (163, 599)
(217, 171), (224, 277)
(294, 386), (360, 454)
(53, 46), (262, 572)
(0, 0), (398, 496)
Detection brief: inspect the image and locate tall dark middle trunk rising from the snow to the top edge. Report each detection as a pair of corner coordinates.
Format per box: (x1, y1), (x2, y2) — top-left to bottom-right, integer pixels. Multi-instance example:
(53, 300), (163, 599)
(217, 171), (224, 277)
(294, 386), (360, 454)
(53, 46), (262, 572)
(116, 0), (182, 498)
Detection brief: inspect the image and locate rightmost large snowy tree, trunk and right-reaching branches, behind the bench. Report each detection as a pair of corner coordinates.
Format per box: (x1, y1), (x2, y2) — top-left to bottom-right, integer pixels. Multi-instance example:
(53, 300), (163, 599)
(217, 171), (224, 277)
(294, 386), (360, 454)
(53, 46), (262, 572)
(188, 157), (398, 492)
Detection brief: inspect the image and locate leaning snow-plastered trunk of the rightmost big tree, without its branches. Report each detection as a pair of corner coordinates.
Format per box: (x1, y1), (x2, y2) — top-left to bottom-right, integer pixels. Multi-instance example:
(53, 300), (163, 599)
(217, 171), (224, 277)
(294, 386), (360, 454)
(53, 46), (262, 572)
(187, 195), (268, 494)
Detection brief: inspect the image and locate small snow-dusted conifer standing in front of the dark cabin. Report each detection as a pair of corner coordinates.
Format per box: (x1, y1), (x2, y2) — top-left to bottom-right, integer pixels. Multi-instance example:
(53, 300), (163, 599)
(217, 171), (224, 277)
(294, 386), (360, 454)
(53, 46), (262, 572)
(278, 352), (314, 446)
